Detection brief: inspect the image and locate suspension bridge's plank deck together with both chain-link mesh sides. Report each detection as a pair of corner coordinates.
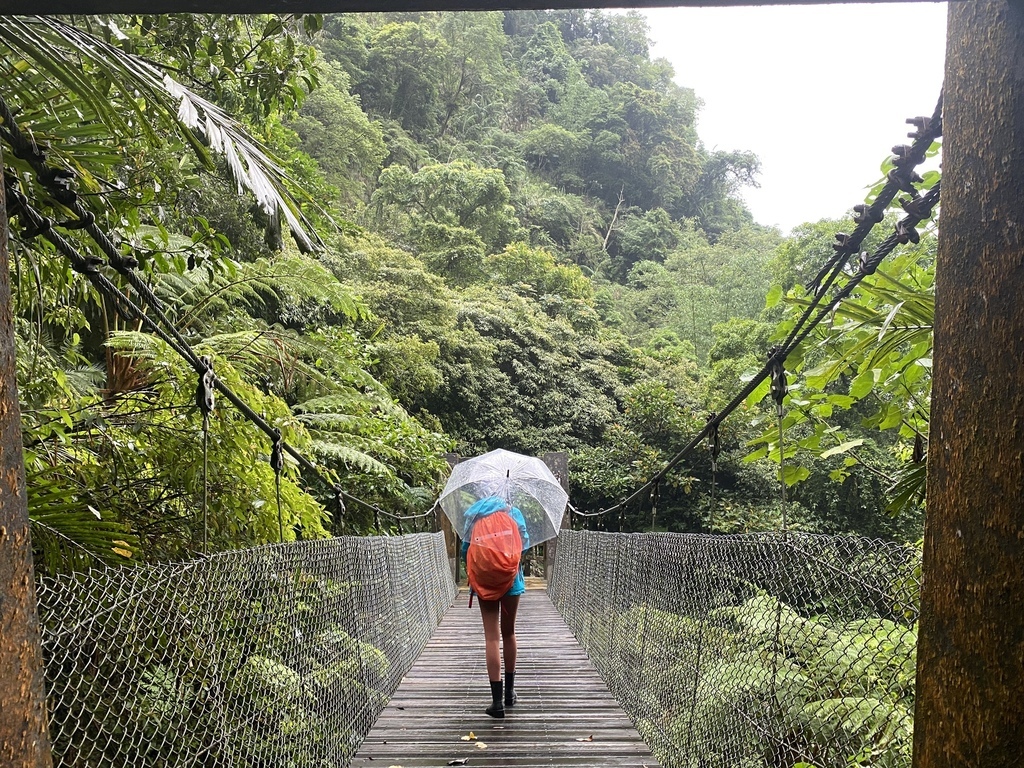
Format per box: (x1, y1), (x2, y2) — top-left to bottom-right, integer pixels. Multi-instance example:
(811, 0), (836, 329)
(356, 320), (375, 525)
(39, 530), (920, 768)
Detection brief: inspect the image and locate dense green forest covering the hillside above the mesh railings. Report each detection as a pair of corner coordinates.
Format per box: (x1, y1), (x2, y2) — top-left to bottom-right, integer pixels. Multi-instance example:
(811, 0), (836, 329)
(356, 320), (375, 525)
(0, 10), (937, 571)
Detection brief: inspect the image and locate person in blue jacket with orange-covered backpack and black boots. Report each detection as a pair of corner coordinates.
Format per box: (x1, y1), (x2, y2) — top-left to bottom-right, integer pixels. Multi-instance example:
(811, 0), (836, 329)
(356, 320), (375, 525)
(462, 496), (529, 718)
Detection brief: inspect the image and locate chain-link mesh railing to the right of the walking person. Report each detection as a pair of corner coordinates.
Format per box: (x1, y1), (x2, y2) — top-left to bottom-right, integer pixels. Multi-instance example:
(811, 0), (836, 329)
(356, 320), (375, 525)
(549, 531), (921, 768)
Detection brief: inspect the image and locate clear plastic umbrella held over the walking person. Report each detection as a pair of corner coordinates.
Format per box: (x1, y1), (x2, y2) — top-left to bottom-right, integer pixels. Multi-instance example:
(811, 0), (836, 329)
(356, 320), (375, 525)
(438, 449), (569, 547)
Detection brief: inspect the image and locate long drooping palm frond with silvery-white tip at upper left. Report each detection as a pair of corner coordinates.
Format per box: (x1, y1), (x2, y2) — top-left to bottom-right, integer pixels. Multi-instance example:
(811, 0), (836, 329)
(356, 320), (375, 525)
(0, 16), (323, 251)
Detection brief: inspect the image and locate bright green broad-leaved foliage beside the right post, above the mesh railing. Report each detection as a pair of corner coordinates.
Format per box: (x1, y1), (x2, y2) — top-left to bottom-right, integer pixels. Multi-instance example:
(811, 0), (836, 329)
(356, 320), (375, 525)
(749, 238), (935, 525)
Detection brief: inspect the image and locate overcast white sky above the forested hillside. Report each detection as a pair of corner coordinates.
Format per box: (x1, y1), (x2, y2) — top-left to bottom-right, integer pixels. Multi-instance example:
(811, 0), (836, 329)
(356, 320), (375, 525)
(645, 2), (946, 232)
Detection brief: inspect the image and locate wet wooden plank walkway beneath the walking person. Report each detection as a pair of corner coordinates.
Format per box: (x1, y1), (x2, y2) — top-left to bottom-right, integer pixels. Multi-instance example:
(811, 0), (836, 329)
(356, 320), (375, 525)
(352, 590), (657, 768)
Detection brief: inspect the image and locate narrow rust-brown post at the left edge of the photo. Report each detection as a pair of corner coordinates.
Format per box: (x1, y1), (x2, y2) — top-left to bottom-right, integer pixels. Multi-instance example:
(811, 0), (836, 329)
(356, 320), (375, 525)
(0, 143), (50, 768)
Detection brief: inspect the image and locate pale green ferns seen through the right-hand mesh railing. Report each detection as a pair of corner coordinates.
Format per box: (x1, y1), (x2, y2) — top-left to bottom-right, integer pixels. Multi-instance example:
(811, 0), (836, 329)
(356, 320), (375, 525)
(591, 594), (916, 768)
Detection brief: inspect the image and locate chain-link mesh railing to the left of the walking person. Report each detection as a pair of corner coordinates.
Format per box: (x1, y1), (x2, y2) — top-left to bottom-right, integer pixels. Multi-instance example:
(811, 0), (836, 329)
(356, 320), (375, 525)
(39, 534), (456, 768)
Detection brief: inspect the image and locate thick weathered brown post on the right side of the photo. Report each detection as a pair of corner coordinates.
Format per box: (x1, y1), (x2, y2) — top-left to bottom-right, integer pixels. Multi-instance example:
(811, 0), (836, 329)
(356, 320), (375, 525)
(913, 0), (1024, 768)
